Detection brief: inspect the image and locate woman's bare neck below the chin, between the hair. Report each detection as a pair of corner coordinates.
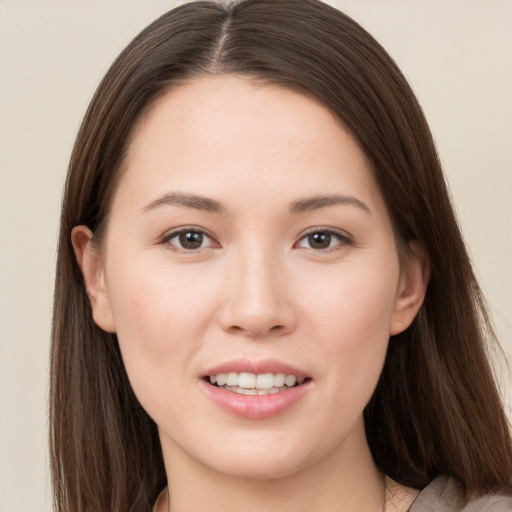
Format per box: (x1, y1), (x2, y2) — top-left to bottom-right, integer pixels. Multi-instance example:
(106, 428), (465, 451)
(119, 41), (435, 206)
(158, 424), (385, 512)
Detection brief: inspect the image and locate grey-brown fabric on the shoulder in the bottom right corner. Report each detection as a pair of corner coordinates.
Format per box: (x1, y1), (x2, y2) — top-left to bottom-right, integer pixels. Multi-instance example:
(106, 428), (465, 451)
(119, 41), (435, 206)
(409, 476), (512, 512)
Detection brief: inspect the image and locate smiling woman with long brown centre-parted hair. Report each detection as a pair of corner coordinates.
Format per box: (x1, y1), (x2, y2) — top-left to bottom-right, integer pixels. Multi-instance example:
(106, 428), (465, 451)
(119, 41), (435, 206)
(51, 0), (512, 512)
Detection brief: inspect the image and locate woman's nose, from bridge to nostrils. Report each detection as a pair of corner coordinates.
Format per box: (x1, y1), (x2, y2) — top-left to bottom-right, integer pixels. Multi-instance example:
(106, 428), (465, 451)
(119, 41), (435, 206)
(220, 252), (297, 338)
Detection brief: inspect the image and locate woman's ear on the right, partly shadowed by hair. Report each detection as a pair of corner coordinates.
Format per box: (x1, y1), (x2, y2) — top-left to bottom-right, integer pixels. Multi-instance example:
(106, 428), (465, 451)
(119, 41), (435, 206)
(390, 241), (430, 336)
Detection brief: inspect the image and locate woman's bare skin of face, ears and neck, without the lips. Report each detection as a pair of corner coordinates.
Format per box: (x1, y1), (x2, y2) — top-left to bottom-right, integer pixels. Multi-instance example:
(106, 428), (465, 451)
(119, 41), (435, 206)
(72, 76), (428, 512)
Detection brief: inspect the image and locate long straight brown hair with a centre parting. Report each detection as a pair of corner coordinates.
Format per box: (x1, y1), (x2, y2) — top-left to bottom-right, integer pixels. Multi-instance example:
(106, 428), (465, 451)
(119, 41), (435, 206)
(50, 0), (512, 512)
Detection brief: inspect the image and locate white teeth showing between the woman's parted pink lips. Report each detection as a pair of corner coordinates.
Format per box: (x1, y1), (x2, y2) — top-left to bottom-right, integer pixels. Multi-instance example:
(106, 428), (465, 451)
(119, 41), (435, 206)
(210, 372), (305, 395)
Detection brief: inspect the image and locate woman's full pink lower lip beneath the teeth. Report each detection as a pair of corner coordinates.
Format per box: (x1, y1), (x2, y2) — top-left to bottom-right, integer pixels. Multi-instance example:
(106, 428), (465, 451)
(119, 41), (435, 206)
(201, 380), (312, 420)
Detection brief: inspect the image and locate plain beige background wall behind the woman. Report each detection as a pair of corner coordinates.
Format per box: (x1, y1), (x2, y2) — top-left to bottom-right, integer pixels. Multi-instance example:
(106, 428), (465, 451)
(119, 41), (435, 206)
(0, 0), (512, 512)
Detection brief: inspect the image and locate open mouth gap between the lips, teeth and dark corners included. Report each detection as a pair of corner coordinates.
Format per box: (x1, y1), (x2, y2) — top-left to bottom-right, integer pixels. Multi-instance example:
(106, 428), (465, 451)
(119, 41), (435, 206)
(204, 372), (311, 396)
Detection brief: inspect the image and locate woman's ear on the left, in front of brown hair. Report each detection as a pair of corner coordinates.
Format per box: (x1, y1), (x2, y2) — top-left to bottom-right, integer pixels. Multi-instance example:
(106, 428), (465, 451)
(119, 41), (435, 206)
(71, 226), (116, 332)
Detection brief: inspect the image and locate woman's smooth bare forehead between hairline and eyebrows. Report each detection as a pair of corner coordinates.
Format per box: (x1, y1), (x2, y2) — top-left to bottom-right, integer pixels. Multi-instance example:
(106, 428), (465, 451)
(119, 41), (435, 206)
(115, 76), (375, 212)
